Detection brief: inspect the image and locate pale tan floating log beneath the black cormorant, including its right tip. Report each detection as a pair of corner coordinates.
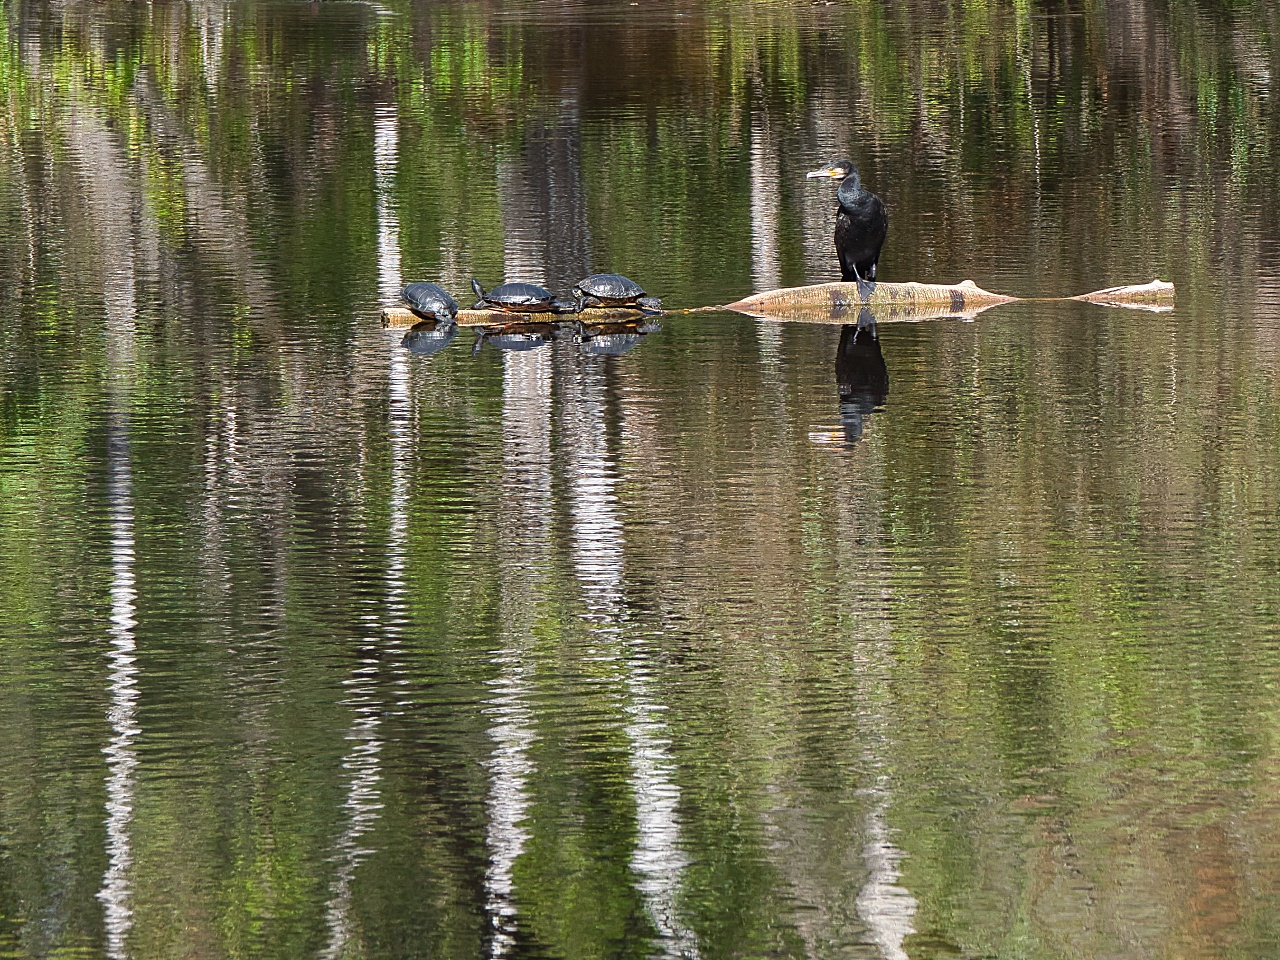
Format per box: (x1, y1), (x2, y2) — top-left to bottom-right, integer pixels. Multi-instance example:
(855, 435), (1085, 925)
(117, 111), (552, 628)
(724, 280), (1174, 324)
